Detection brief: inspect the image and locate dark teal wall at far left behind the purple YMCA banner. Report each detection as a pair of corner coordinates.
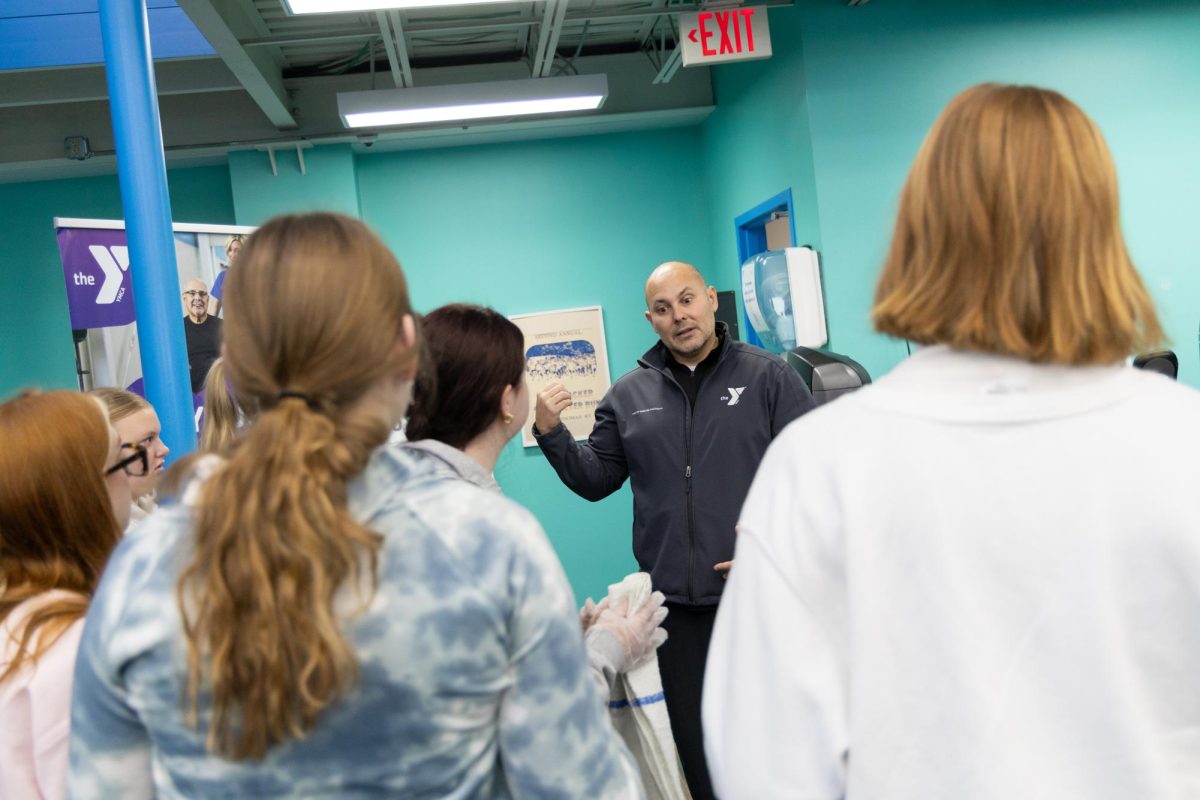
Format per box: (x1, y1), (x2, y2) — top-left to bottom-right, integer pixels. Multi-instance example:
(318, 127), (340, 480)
(0, 166), (233, 397)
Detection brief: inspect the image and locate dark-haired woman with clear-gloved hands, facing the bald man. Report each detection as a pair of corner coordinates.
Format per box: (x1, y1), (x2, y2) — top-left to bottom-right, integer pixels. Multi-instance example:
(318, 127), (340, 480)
(404, 303), (667, 698)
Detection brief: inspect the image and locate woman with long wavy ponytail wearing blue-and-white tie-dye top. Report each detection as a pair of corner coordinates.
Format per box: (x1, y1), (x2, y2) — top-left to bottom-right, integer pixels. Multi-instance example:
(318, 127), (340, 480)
(70, 213), (641, 799)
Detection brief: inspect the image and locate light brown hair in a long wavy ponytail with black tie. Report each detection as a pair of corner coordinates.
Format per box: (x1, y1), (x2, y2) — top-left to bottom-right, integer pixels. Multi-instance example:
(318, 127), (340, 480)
(178, 213), (416, 759)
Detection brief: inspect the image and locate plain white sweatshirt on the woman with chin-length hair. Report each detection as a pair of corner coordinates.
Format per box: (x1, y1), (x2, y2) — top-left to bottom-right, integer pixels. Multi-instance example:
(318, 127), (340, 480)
(703, 348), (1200, 800)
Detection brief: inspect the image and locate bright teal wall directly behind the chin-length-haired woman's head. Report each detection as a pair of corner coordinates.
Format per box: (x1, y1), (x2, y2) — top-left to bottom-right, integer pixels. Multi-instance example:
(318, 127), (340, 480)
(796, 0), (1200, 386)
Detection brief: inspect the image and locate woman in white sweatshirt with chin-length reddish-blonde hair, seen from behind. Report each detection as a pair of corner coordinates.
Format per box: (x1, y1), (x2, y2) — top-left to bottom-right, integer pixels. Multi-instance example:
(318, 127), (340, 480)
(704, 85), (1200, 800)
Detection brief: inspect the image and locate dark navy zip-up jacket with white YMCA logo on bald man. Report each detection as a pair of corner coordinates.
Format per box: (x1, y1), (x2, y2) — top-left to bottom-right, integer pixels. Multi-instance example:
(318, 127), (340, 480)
(534, 323), (814, 606)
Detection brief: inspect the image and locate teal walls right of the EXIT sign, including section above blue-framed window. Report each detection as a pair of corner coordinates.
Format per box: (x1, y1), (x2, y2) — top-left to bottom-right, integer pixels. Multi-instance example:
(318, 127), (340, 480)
(703, 0), (1200, 386)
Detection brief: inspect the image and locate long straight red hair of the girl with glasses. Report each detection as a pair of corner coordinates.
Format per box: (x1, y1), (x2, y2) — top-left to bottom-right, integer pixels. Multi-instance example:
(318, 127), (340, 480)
(0, 391), (121, 681)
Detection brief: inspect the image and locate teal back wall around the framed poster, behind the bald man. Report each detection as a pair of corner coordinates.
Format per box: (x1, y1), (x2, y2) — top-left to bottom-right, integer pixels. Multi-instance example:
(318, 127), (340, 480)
(358, 128), (712, 599)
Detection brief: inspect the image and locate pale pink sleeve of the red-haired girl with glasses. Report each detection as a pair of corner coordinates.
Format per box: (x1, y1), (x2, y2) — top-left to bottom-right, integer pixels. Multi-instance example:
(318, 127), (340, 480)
(29, 619), (84, 800)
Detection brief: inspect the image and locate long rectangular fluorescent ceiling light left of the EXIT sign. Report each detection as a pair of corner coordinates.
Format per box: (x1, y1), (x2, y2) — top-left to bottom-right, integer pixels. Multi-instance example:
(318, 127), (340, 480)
(337, 74), (608, 128)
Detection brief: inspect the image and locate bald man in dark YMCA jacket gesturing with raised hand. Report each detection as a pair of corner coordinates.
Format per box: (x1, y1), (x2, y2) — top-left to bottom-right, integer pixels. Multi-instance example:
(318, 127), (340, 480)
(534, 261), (814, 800)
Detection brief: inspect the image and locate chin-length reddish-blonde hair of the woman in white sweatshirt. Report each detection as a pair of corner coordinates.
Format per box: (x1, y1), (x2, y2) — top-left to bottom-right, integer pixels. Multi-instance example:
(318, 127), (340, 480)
(871, 84), (1163, 365)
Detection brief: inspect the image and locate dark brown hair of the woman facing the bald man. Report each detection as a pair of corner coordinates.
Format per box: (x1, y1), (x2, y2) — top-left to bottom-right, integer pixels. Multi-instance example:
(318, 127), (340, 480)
(404, 303), (524, 450)
